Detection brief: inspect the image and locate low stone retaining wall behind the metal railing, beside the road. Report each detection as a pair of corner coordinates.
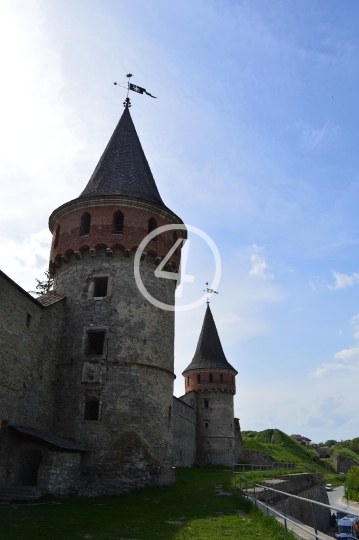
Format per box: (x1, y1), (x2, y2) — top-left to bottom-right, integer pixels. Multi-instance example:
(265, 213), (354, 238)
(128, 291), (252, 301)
(260, 473), (330, 532)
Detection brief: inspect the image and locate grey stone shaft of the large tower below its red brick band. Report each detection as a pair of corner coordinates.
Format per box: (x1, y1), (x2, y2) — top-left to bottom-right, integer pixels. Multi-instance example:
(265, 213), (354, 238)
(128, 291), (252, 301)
(55, 249), (175, 495)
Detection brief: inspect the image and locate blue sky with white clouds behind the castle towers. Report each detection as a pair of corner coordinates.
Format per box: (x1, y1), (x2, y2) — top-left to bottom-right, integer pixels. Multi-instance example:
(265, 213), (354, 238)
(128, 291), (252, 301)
(0, 0), (359, 442)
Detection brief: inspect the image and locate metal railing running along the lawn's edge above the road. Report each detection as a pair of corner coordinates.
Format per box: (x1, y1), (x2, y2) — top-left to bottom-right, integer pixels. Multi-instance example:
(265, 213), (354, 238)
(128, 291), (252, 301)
(233, 472), (359, 540)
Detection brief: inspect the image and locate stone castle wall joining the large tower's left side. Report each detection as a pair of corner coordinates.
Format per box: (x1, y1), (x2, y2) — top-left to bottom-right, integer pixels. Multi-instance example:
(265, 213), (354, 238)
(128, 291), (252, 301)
(0, 272), (63, 429)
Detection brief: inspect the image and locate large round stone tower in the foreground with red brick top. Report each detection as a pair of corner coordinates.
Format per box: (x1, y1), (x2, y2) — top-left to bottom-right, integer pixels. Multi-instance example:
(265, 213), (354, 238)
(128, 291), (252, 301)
(49, 101), (186, 495)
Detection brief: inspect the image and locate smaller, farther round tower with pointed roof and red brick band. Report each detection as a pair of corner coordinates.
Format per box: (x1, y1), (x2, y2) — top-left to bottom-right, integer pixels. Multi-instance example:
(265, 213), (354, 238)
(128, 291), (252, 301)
(182, 304), (237, 466)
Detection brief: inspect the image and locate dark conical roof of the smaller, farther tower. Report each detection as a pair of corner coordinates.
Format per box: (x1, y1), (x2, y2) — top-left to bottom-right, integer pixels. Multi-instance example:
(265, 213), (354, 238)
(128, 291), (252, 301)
(183, 304), (237, 375)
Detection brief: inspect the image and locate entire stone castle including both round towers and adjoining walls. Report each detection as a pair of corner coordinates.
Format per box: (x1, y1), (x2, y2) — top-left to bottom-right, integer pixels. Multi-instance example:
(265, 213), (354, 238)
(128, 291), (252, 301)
(0, 100), (243, 496)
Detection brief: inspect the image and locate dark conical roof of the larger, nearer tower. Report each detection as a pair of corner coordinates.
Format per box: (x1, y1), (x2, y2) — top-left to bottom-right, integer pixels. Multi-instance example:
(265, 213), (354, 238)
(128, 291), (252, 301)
(80, 107), (165, 206)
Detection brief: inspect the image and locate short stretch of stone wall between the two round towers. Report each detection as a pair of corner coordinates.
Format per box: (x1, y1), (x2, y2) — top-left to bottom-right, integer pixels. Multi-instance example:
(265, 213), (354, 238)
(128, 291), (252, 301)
(173, 392), (196, 467)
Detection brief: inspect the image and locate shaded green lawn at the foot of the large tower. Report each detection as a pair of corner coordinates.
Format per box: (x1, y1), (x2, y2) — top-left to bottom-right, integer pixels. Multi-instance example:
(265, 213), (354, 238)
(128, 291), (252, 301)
(0, 469), (294, 540)
